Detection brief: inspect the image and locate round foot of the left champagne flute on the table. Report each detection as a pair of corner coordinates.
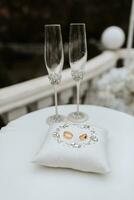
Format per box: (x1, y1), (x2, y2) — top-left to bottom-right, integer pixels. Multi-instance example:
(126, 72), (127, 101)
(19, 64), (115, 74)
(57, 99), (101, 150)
(47, 115), (66, 125)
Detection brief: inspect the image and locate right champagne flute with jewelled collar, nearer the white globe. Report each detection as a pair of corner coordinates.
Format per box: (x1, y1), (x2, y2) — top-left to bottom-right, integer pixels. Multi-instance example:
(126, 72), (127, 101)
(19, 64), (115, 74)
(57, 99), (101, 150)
(68, 23), (88, 122)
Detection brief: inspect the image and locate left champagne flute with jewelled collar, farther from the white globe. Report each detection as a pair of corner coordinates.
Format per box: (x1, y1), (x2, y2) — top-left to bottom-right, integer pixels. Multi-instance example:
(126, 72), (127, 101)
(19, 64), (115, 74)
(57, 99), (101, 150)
(44, 24), (65, 124)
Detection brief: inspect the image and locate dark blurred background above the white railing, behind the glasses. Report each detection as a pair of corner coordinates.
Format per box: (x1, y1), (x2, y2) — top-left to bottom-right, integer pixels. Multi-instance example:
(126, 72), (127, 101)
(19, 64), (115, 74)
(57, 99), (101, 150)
(0, 0), (131, 88)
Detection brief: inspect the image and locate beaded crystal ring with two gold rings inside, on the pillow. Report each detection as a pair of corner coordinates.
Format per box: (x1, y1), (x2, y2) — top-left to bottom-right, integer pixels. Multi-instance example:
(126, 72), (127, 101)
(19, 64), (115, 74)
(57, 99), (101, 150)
(52, 123), (98, 148)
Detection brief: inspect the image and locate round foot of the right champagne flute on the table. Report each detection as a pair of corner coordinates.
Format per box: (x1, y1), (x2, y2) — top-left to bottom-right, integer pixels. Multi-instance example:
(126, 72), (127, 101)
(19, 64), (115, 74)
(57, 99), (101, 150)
(68, 112), (88, 123)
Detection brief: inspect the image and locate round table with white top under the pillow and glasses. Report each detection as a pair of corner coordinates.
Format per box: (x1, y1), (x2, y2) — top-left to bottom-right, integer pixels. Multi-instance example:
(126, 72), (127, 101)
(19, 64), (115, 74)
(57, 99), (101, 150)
(0, 105), (134, 200)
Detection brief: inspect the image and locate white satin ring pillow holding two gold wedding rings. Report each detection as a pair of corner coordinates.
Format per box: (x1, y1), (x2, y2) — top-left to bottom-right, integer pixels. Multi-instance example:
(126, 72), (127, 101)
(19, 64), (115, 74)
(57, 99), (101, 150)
(33, 122), (110, 174)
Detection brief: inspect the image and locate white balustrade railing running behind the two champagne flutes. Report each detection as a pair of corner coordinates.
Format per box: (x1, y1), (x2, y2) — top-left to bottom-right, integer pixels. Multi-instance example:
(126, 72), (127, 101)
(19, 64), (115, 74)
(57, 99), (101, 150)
(0, 51), (118, 123)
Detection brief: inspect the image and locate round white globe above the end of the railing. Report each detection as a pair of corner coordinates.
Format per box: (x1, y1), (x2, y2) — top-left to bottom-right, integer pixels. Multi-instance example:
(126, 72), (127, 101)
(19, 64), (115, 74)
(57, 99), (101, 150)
(101, 26), (125, 50)
